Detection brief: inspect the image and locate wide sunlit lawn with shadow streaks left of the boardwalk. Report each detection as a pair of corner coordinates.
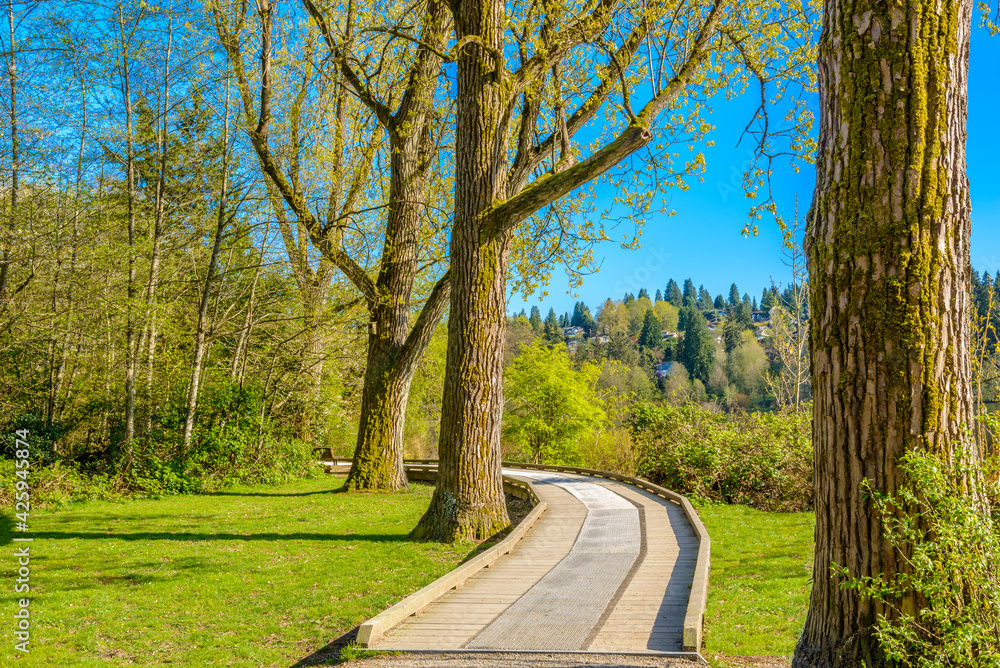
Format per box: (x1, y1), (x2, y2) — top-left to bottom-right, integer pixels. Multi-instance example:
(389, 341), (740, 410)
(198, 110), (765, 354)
(0, 477), (473, 668)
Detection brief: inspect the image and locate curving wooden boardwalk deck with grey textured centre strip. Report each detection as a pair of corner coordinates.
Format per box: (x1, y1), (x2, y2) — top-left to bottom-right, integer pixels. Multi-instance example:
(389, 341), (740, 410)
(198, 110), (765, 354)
(374, 469), (699, 653)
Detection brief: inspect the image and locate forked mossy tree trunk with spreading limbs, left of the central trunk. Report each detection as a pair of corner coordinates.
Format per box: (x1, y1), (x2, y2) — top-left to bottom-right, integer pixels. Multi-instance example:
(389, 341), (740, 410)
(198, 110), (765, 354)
(213, 0), (450, 490)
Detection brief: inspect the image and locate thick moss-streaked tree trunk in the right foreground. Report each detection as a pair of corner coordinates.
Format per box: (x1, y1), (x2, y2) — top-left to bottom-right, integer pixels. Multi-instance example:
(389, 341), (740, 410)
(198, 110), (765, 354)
(793, 0), (972, 668)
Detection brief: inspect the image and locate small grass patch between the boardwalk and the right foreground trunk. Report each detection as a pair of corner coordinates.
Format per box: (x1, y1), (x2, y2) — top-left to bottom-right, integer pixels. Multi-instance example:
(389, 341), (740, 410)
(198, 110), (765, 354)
(698, 505), (814, 665)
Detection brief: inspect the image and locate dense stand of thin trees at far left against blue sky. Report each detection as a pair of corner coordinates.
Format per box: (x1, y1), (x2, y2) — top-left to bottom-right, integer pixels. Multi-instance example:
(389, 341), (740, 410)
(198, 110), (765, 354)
(0, 2), (366, 495)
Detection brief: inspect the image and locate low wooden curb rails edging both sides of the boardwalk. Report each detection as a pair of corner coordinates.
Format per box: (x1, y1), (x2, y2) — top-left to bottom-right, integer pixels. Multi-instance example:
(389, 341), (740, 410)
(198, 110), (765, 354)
(326, 459), (711, 652)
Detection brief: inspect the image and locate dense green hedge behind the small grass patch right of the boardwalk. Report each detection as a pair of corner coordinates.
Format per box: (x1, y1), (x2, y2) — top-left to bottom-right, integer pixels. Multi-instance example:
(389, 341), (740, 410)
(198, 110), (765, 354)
(628, 403), (813, 511)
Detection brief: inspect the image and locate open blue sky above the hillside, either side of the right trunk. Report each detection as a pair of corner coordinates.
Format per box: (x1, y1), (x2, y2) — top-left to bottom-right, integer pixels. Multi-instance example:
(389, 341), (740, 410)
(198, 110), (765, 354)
(509, 28), (1000, 316)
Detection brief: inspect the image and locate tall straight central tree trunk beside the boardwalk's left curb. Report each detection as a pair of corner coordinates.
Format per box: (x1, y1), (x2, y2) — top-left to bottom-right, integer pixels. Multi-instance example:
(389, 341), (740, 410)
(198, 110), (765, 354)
(414, 0), (510, 541)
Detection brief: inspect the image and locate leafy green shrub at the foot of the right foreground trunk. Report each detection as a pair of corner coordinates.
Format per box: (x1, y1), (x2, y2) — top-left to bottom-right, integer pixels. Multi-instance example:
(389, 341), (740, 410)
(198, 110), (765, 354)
(835, 446), (1000, 668)
